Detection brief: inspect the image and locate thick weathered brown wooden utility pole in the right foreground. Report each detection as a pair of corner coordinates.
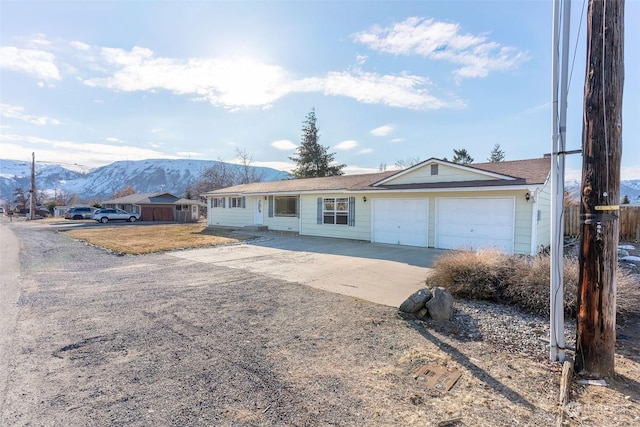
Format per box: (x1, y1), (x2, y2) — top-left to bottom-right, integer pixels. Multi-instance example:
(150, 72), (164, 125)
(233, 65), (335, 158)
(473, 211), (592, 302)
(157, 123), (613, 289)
(575, 0), (624, 378)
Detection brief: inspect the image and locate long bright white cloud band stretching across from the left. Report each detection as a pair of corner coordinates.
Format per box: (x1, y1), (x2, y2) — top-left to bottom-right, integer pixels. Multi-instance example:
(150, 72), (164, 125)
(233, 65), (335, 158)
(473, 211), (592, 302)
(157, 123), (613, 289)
(2, 40), (464, 111)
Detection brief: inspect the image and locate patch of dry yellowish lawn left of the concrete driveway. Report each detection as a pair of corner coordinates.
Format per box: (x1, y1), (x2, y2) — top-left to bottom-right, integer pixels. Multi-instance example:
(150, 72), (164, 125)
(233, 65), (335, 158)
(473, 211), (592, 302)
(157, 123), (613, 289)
(67, 224), (251, 255)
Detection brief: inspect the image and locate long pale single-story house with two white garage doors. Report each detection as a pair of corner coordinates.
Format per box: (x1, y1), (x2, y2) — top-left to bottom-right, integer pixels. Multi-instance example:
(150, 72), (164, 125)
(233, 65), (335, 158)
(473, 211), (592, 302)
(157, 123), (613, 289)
(205, 158), (551, 255)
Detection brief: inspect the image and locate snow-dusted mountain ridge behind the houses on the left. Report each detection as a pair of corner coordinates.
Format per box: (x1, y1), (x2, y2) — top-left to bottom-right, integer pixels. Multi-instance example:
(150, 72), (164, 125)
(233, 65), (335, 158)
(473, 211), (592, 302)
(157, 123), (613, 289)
(0, 159), (288, 201)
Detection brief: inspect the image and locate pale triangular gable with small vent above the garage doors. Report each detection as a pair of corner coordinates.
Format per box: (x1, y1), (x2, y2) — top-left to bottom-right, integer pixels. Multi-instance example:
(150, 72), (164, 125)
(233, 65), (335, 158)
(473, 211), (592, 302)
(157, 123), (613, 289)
(374, 159), (514, 186)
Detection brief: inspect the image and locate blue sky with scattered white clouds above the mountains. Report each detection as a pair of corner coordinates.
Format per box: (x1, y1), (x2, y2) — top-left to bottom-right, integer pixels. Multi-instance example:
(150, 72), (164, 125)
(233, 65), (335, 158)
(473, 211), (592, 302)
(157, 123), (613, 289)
(0, 0), (640, 179)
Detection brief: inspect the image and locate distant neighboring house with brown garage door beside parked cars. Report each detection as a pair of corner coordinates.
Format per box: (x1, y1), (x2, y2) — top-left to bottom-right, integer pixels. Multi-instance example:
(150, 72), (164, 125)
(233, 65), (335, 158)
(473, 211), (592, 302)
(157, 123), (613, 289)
(102, 193), (205, 222)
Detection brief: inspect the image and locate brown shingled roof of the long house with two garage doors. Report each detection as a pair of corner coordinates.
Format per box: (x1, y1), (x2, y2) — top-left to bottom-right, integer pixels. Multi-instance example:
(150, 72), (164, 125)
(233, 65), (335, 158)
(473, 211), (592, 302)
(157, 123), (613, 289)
(205, 158), (551, 197)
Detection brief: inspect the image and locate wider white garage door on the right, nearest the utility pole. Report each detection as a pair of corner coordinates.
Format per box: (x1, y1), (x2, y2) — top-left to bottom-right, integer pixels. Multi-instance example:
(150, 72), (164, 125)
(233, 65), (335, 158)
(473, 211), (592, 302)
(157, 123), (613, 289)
(435, 198), (515, 253)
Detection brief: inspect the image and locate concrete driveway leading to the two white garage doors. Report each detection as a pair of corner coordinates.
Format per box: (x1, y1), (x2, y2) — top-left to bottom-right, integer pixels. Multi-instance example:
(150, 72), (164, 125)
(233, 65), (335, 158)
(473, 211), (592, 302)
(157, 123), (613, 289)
(170, 233), (443, 307)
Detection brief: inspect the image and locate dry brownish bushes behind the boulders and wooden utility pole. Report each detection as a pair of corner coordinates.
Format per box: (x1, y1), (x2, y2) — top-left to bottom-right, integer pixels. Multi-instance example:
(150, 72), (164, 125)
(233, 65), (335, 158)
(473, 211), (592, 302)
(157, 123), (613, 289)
(427, 250), (640, 317)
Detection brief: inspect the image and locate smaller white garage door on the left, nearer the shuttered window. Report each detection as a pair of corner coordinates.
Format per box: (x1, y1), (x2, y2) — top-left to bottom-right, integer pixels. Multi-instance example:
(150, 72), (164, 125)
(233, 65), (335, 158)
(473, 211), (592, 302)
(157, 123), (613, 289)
(371, 199), (429, 247)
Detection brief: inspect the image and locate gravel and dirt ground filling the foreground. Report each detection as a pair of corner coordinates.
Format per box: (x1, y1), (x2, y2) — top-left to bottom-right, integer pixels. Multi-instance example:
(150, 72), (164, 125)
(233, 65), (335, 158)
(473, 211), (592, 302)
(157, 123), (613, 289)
(0, 222), (640, 426)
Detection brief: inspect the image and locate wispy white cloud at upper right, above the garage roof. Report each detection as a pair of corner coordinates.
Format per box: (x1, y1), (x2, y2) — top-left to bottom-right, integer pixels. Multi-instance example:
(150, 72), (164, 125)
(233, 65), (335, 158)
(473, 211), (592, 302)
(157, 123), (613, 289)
(353, 17), (529, 79)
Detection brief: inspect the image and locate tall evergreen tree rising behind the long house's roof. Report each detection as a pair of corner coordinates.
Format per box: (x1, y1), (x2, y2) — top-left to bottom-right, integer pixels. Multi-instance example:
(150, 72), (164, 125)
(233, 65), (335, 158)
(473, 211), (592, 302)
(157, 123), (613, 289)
(289, 109), (346, 178)
